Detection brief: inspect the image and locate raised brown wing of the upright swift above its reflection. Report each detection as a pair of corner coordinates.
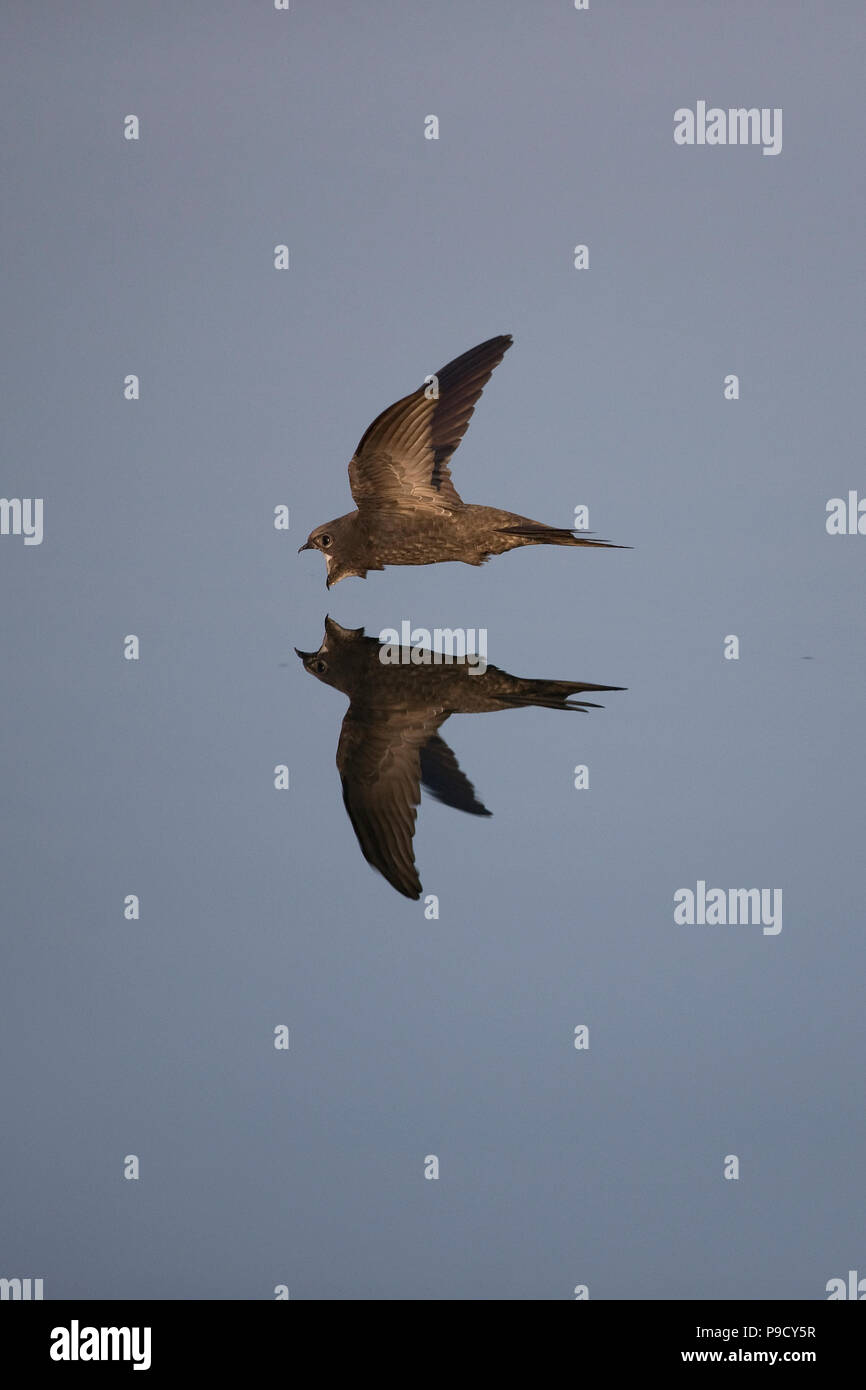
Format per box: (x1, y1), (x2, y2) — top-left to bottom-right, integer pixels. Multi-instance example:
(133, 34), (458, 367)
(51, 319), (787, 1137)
(349, 334), (512, 512)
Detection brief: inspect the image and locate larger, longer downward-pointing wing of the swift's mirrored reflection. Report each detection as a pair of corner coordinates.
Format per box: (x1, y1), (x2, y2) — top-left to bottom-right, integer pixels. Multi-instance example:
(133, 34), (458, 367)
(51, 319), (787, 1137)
(336, 705), (446, 898)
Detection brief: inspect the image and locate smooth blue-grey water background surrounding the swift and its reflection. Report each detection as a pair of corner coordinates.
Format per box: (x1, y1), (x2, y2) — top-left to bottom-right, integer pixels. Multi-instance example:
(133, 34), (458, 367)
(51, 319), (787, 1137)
(0, 0), (866, 1300)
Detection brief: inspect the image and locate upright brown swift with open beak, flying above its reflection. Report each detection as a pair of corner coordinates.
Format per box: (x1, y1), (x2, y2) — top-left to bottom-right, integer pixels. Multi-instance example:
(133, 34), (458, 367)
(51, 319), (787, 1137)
(297, 334), (627, 588)
